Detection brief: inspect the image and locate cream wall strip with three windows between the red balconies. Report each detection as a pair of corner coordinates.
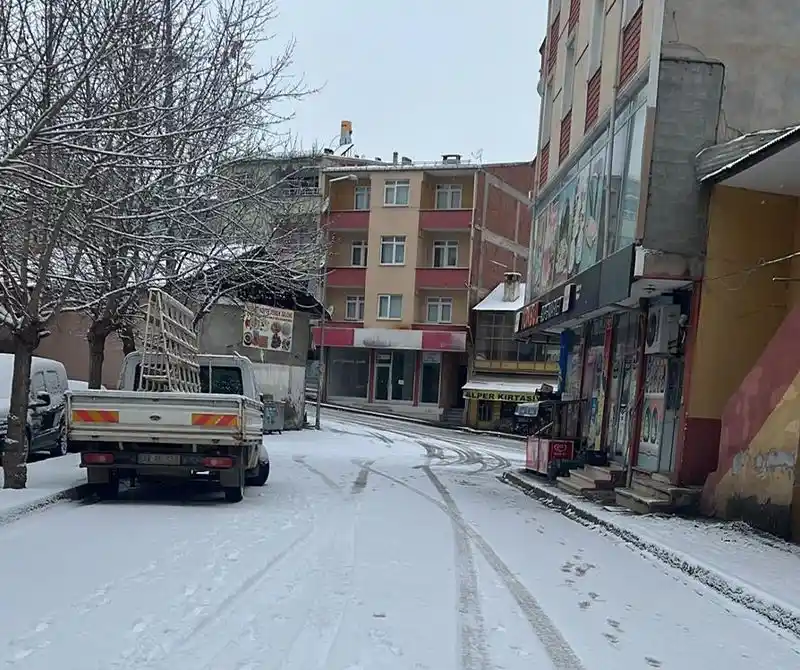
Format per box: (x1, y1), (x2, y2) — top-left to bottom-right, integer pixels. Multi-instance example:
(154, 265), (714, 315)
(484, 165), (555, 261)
(364, 171), (423, 328)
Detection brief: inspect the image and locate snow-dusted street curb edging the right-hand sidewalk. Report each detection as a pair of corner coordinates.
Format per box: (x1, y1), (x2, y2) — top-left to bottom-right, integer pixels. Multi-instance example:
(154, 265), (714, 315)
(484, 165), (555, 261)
(498, 470), (800, 637)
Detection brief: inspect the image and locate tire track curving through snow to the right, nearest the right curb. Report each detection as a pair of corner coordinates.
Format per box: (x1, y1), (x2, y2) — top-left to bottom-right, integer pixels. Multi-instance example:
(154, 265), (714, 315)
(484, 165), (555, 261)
(370, 468), (585, 670)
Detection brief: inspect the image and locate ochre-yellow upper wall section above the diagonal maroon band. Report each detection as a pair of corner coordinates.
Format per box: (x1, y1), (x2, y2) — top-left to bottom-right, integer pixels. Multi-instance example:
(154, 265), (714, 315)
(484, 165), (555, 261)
(687, 187), (800, 419)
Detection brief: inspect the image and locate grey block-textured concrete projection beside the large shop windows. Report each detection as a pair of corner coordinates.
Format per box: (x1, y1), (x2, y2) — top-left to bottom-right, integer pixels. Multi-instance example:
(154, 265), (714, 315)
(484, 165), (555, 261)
(642, 58), (723, 257)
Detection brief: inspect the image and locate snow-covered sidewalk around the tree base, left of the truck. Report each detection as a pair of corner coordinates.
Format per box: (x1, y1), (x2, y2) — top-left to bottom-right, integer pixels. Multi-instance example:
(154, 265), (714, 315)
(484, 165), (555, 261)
(0, 454), (86, 524)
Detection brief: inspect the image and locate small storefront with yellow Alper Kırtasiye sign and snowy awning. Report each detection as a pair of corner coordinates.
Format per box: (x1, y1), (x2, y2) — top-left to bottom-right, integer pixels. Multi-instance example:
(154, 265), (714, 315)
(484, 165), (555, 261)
(462, 375), (552, 433)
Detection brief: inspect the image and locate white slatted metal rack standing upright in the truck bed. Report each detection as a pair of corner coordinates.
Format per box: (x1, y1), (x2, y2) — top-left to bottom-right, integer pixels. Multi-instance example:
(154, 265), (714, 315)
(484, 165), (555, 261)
(138, 289), (201, 393)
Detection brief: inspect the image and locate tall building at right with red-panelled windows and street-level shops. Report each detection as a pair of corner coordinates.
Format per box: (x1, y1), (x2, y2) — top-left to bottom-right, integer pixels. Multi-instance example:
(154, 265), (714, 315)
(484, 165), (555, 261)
(518, 0), (800, 507)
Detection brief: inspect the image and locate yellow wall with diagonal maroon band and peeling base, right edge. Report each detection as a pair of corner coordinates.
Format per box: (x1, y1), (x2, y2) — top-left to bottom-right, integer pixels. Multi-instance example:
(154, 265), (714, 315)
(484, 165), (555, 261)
(686, 187), (800, 537)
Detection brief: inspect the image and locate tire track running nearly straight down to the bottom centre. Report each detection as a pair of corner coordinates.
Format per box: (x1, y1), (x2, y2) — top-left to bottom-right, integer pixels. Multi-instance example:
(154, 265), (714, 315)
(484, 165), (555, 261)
(421, 465), (492, 670)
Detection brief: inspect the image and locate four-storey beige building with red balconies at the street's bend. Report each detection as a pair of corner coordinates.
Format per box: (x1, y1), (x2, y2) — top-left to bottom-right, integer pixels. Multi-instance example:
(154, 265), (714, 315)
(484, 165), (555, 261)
(314, 155), (534, 420)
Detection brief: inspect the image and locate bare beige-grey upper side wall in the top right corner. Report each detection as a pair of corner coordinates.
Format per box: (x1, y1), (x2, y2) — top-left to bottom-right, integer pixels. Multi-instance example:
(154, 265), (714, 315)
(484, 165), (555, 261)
(660, 0), (800, 140)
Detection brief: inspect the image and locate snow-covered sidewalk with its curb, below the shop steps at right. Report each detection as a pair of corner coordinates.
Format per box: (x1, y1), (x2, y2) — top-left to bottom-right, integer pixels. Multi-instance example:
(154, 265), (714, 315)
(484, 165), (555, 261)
(503, 471), (800, 635)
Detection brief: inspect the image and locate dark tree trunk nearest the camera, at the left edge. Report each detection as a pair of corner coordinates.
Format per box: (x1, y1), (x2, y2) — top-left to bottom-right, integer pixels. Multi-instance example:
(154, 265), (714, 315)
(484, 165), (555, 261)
(3, 324), (39, 489)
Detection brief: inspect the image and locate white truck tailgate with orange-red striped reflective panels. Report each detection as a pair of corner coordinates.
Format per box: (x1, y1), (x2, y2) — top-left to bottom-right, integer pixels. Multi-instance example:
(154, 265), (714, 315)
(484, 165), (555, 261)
(67, 390), (261, 445)
